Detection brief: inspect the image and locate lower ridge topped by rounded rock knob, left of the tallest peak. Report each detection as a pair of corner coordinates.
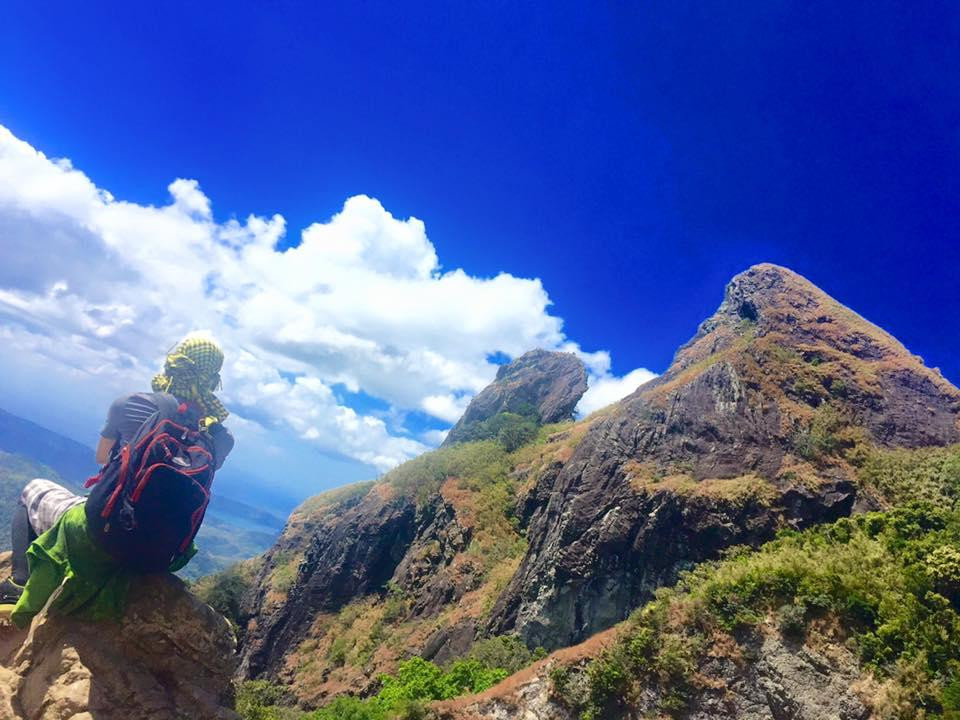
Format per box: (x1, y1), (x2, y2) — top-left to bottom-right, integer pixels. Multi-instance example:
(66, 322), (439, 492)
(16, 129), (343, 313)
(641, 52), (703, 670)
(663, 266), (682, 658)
(238, 351), (586, 702)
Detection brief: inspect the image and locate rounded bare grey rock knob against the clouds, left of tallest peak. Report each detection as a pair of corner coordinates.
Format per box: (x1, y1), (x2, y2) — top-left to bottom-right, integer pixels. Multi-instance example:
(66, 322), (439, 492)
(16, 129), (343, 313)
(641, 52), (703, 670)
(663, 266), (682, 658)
(444, 350), (587, 445)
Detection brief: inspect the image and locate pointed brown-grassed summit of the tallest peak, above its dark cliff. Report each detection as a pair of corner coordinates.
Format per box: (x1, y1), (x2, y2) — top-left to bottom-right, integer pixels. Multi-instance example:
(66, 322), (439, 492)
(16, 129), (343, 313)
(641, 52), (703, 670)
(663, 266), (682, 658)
(633, 263), (960, 447)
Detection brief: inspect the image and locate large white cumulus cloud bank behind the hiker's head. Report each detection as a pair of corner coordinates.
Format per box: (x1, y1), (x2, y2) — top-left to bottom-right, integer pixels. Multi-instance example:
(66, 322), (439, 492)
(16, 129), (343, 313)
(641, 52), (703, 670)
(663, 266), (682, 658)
(0, 126), (652, 470)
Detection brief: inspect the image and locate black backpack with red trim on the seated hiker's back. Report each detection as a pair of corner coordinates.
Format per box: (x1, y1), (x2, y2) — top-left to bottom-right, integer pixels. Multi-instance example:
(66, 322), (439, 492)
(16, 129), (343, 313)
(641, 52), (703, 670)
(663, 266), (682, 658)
(86, 393), (216, 573)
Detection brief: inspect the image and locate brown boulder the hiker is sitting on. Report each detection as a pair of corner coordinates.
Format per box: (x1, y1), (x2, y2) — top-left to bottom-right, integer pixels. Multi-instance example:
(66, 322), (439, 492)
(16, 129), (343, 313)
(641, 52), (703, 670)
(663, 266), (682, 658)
(0, 556), (237, 720)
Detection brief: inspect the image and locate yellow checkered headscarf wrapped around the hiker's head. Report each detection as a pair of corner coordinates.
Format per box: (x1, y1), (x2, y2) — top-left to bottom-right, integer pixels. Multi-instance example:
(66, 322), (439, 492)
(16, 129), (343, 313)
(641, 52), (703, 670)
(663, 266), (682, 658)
(152, 337), (230, 426)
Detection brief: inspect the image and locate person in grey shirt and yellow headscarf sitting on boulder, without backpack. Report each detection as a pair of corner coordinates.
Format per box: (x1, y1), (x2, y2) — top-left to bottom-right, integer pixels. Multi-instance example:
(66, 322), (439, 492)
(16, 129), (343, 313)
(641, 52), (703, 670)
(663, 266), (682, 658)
(0, 337), (234, 627)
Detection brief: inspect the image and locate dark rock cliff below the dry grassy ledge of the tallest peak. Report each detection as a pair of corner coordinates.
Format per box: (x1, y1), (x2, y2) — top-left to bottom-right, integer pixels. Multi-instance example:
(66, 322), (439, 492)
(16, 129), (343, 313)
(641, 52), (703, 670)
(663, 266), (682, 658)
(486, 473), (857, 649)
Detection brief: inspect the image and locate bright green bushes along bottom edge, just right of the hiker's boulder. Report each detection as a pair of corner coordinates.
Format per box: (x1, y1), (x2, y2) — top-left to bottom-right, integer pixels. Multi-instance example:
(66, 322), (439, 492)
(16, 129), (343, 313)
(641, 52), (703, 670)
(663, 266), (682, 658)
(237, 657), (510, 720)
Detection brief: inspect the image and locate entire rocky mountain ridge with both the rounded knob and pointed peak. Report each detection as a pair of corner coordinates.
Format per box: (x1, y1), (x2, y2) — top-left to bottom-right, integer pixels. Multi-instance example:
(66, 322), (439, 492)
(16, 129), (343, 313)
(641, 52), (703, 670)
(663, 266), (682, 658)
(234, 265), (960, 705)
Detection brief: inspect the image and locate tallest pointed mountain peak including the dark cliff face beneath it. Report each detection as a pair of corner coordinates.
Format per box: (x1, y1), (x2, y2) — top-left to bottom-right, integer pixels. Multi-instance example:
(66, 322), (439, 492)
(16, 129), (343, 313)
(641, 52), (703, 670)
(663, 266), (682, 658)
(487, 265), (960, 648)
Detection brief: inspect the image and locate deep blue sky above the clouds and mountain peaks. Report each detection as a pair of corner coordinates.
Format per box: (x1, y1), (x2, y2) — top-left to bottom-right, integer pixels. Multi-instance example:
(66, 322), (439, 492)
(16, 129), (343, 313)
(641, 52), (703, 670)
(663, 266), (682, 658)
(0, 1), (960, 500)
